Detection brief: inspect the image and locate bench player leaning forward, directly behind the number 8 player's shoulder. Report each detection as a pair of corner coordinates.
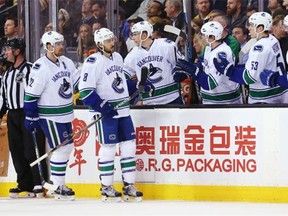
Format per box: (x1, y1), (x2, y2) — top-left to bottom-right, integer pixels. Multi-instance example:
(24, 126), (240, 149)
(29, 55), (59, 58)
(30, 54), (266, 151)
(124, 21), (184, 105)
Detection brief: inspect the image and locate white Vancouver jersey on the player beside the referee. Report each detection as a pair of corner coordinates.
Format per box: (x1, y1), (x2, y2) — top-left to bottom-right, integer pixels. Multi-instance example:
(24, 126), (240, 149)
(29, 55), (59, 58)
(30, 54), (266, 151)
(25, 56), (79, 123)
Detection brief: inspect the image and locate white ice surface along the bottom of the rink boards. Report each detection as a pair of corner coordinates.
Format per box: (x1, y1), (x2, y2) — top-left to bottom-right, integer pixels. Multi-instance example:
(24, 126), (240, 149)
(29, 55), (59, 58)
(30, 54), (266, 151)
(0, 197), (288, 216)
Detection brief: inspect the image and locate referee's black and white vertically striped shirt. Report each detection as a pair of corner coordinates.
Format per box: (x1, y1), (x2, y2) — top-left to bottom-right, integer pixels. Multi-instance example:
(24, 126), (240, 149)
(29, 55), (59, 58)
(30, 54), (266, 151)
(0, 60), (32, 118)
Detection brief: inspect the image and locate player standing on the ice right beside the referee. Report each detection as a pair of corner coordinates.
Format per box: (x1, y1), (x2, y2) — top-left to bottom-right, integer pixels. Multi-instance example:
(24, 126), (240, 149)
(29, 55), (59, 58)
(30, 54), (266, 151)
(24, 31), (79, 200)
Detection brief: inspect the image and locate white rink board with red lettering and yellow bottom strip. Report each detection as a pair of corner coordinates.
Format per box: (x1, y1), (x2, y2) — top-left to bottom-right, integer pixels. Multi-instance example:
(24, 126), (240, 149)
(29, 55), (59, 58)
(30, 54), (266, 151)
(0, 107), (288, 202)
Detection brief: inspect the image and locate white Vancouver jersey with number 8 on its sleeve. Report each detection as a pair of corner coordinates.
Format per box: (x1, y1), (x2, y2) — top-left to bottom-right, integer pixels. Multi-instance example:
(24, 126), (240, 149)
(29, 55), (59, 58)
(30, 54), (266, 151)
(79, 52), (130, 118)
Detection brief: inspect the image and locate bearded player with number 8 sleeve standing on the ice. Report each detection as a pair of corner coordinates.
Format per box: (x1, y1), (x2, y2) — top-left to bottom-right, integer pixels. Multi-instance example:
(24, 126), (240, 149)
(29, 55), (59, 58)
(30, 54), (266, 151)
(79, 28), (149, 201)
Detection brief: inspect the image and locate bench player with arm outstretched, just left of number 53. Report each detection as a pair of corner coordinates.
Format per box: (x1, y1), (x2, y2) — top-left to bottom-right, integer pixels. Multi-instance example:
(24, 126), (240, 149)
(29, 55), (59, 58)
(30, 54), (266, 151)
(174, 21), (243, 104)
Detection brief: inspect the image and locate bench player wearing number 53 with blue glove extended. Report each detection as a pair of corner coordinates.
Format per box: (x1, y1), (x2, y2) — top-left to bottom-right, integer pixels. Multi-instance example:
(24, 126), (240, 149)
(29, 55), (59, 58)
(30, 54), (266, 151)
(214, 12), (287, 104)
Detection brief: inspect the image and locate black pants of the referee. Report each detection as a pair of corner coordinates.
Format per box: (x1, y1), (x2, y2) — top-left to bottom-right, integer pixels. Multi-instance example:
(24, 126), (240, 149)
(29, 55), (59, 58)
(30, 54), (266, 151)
(7, 109), (47, 191)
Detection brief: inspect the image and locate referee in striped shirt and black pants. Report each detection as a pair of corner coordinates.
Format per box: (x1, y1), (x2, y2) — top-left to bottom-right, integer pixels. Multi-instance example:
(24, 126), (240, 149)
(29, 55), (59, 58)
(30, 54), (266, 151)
(0, 38), (47, 197)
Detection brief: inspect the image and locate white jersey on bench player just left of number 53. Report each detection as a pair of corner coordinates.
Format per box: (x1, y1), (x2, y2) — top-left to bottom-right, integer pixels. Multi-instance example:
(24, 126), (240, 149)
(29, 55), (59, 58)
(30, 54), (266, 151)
(201, 43), (243, 104)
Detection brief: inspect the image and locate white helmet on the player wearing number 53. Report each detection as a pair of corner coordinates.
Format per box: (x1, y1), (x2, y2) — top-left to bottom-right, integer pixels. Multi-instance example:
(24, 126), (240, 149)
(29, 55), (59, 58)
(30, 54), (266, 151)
(249, 12), (272, 31)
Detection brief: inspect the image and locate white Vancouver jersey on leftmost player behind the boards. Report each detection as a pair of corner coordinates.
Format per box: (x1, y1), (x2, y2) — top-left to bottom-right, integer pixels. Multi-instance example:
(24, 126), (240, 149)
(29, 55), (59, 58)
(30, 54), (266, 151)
(124, 38), (184, 105)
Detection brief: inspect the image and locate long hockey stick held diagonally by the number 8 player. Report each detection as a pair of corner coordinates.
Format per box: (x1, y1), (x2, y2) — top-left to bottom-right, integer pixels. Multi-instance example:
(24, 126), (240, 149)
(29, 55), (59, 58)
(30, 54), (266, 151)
(30, 67), (148, 167)
